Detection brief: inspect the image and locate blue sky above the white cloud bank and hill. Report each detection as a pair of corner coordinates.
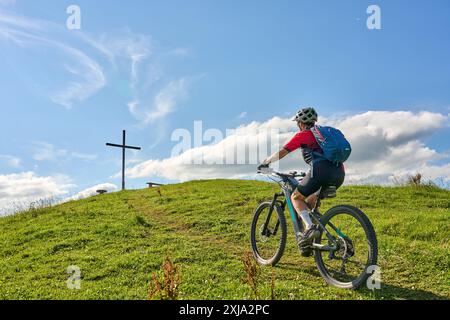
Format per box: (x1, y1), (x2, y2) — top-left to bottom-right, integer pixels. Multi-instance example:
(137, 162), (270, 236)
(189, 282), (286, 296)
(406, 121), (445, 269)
(0, 0), (450, 212)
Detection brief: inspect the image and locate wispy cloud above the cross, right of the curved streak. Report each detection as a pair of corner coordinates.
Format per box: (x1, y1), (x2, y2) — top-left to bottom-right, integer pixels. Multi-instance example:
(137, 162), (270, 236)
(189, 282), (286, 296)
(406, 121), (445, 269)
(68, 29), (198, 126)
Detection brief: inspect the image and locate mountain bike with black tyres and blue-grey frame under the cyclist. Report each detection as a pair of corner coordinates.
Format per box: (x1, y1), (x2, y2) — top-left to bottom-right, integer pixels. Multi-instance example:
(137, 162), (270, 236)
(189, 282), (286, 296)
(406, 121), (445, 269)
(250, 169), (378, 289)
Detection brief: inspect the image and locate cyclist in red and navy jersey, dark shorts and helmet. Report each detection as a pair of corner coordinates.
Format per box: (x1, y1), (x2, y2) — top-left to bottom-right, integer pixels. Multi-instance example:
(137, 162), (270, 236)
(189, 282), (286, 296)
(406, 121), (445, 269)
(260, 108), (345, 248)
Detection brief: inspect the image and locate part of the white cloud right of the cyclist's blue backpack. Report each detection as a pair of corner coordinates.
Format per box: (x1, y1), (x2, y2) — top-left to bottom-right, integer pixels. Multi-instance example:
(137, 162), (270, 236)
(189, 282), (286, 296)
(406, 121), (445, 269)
(336, 111), (449, 183)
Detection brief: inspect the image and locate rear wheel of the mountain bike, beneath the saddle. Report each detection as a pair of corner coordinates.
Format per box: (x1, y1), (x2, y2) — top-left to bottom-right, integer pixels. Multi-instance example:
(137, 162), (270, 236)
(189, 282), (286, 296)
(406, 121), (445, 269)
(314, 206), (378, 289)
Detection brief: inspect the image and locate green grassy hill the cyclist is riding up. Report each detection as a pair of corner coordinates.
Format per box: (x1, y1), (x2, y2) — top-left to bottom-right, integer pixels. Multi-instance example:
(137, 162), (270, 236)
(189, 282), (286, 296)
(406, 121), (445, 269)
(0, 180), (450, 299)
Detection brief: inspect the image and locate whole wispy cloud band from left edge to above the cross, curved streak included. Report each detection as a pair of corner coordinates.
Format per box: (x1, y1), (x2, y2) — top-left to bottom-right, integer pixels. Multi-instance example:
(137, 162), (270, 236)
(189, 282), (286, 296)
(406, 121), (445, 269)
(0, 13), (194, 125)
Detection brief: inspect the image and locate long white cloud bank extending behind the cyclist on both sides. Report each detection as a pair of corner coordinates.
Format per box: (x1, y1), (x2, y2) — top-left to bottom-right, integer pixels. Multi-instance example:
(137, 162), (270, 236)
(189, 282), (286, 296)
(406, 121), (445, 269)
(128, 111), (450, 183)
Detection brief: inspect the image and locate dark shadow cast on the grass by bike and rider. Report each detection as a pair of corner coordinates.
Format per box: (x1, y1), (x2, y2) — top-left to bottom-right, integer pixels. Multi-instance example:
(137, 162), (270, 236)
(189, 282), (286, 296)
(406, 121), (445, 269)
(277, 263), (449, 300)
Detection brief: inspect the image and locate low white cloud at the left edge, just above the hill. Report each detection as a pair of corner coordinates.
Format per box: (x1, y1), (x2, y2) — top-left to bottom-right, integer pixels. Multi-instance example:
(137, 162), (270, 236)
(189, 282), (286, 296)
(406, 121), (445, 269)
(0, 172), (75, 215)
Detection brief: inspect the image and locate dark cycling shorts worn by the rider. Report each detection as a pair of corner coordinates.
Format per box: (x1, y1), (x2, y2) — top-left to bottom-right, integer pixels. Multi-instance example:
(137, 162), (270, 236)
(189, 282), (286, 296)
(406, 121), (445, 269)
(297, 160), (345, 198)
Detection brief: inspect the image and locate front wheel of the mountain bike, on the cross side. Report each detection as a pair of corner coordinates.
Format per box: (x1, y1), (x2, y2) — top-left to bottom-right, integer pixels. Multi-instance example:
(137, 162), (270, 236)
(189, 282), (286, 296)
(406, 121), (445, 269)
(250, 202), (287, 266)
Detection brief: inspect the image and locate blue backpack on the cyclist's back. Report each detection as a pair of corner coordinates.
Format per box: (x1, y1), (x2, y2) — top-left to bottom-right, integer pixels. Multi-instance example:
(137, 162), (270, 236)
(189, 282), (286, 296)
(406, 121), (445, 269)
(311, 126), (352, 165)
